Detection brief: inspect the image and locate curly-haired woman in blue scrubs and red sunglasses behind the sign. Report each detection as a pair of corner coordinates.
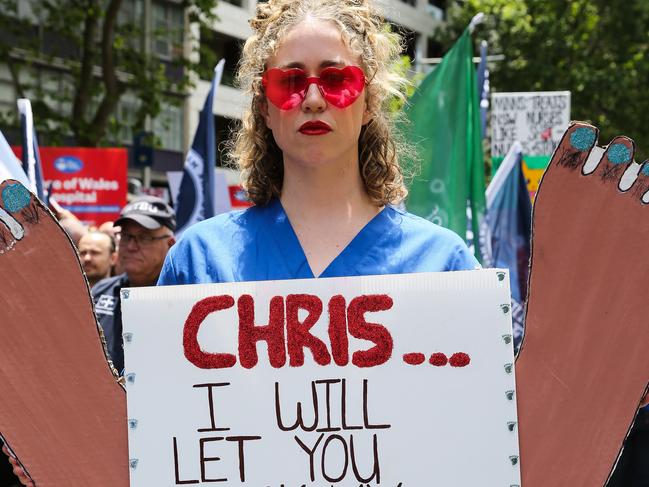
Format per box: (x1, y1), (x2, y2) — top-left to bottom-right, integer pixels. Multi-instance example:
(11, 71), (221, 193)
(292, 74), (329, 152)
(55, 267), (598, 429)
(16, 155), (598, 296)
(158, 0), (478, 285)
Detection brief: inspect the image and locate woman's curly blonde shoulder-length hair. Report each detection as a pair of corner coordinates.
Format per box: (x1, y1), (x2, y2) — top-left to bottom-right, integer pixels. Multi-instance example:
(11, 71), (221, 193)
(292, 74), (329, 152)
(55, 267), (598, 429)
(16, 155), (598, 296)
(230, 0), (407, 206)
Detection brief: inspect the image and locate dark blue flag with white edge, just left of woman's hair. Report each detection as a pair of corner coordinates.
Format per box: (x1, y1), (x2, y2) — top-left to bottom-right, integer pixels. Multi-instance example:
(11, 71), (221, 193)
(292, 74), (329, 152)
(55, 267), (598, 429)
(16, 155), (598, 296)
(176, 59), (225, 237)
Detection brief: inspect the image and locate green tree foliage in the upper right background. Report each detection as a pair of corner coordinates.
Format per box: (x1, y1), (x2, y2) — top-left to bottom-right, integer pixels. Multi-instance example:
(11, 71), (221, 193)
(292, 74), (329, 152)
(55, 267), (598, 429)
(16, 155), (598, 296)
(438, 0), (649, 161)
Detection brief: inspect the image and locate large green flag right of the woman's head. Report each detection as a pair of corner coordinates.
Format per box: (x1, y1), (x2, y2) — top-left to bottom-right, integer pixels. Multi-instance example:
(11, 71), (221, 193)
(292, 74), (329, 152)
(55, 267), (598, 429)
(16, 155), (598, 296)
(405, 29), (488, 261)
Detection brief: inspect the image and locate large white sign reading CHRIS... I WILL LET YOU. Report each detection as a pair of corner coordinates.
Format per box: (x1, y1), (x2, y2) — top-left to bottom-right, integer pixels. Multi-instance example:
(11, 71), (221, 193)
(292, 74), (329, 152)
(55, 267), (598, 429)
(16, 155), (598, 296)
(122, 269), (520, 487)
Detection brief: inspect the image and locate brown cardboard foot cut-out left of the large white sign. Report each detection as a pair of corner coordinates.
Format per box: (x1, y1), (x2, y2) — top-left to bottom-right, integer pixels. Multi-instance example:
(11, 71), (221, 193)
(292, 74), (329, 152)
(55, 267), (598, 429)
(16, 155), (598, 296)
(0, 181), (128, 487)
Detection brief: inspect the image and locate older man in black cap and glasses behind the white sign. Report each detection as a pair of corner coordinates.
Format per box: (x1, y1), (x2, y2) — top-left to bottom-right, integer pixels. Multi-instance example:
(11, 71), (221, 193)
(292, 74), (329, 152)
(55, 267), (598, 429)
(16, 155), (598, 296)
(92, 196), (176, 374)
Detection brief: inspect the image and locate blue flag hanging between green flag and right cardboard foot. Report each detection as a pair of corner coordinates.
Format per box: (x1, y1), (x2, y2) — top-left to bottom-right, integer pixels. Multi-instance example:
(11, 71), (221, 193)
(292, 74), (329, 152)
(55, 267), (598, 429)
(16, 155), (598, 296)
(487, 142), (532, 350)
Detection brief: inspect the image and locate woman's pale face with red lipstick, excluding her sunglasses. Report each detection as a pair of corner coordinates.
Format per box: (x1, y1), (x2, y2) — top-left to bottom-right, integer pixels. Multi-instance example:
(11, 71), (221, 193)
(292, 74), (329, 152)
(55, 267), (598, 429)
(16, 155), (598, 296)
(262, 19), (369, 171)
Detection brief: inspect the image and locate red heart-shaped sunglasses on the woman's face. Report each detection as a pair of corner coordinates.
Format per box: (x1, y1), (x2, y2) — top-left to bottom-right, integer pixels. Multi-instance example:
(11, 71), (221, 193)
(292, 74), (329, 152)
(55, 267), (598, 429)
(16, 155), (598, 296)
(261, 66), (365, 110)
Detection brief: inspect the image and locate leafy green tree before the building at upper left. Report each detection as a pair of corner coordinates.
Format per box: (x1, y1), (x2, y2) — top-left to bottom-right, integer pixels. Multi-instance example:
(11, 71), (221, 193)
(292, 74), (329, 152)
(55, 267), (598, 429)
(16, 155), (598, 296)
(0, 0), (216, 146)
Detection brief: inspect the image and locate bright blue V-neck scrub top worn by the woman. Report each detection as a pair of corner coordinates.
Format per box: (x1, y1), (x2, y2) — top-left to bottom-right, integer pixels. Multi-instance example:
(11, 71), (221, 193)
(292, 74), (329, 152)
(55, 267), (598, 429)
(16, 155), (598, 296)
(158, 198), (479, 285)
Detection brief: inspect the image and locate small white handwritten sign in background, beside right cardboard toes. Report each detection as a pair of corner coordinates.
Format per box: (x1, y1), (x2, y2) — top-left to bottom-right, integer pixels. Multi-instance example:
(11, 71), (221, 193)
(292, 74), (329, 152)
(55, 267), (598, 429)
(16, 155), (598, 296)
(491, 91), (570, 157)
